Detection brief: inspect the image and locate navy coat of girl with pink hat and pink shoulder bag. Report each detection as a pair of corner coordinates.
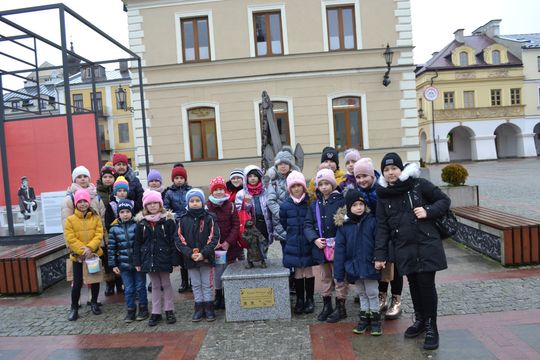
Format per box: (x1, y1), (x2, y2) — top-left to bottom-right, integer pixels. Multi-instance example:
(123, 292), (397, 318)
(304, 190), (345, 265)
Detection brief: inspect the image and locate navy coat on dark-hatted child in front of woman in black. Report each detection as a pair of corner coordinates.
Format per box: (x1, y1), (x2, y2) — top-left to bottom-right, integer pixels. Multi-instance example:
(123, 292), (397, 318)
(334, 208), (380, 284)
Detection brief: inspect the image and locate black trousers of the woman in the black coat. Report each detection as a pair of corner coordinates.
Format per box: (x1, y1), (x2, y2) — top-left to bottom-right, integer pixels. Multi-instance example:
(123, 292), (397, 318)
(407, 271), (438, 318)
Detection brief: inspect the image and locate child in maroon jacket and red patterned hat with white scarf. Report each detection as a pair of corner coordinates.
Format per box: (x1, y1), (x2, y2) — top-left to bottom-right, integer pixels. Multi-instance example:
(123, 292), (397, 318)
(206, 176), (241, 309)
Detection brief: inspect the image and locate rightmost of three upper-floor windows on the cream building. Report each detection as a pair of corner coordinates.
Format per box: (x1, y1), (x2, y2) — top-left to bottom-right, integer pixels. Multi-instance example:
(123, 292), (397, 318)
(326, 6), (356, 51)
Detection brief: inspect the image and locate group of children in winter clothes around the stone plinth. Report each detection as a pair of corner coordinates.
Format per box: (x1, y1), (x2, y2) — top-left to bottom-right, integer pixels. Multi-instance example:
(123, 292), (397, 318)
(61, 147), (446, 348)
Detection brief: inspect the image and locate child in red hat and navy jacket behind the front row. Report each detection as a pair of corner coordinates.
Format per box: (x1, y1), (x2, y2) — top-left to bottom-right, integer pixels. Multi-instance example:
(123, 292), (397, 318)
(163, 164), (191, 293)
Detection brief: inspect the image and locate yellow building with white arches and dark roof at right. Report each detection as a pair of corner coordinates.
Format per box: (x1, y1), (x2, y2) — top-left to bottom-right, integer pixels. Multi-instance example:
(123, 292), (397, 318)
(416, 20), (540, 163)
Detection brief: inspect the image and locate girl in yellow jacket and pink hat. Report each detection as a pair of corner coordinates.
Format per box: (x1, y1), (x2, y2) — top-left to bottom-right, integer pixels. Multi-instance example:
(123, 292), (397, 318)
(64, 189), (103, 321)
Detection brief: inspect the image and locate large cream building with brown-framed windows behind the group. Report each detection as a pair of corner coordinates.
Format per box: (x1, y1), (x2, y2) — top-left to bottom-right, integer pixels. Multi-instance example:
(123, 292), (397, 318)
(124, 0), (419, 185)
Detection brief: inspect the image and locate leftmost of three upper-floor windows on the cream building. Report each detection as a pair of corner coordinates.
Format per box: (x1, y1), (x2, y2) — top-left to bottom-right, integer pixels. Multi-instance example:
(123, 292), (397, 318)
(180, 16), (210, 62)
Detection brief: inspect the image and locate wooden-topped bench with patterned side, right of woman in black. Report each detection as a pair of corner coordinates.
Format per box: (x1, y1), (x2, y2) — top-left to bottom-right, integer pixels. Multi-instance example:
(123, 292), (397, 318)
(452, 206), (540, 266)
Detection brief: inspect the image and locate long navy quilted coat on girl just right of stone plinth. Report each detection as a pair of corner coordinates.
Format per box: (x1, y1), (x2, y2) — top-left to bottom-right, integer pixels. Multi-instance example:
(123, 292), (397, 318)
(279, 195), (315, 268)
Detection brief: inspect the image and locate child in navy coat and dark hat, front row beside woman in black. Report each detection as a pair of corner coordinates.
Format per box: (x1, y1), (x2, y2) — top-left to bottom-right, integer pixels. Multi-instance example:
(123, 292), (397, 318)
(334, 189), (382, 336)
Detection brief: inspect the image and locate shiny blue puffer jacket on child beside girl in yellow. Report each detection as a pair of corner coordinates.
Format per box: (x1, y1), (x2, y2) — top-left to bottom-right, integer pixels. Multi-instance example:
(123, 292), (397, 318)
(108, 219), (137, 271)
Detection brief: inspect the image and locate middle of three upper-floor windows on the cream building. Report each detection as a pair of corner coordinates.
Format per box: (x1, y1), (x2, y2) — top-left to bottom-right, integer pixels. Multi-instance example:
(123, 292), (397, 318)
(253, 12), (283, 56)
